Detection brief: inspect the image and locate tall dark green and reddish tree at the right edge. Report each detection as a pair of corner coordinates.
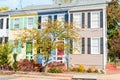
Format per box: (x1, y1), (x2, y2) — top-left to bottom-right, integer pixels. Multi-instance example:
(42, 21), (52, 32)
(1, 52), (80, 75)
(107, 0), (120, 60)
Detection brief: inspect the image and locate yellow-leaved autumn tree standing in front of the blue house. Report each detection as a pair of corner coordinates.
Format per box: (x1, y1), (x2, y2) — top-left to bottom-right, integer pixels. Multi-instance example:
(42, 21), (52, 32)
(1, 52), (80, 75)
(18, 21), (80, 72)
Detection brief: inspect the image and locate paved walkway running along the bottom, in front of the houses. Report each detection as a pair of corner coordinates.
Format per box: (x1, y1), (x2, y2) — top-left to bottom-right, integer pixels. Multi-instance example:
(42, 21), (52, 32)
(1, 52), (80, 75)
(0, 72), (120, 80)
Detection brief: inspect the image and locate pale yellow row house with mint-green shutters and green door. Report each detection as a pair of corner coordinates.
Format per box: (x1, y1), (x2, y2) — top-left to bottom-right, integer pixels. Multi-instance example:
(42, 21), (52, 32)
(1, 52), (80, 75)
(9, 10), (38, 60)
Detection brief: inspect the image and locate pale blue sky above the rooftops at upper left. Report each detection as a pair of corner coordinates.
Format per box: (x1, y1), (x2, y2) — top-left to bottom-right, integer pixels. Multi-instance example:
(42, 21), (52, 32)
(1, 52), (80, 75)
(0, 0), (53, 9)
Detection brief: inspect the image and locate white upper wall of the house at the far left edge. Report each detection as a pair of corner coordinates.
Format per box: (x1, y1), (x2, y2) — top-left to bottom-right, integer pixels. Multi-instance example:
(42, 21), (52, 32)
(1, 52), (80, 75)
(0, 15), (9, 43)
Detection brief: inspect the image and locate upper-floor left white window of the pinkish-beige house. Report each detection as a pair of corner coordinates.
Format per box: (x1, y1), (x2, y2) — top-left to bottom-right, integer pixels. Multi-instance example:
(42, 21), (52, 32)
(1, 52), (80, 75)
(73, 12), (82, 28)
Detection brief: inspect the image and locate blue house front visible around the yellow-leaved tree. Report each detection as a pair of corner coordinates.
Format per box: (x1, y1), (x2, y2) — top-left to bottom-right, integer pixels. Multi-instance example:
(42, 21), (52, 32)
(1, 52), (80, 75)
(38, 9), (69, 63)
